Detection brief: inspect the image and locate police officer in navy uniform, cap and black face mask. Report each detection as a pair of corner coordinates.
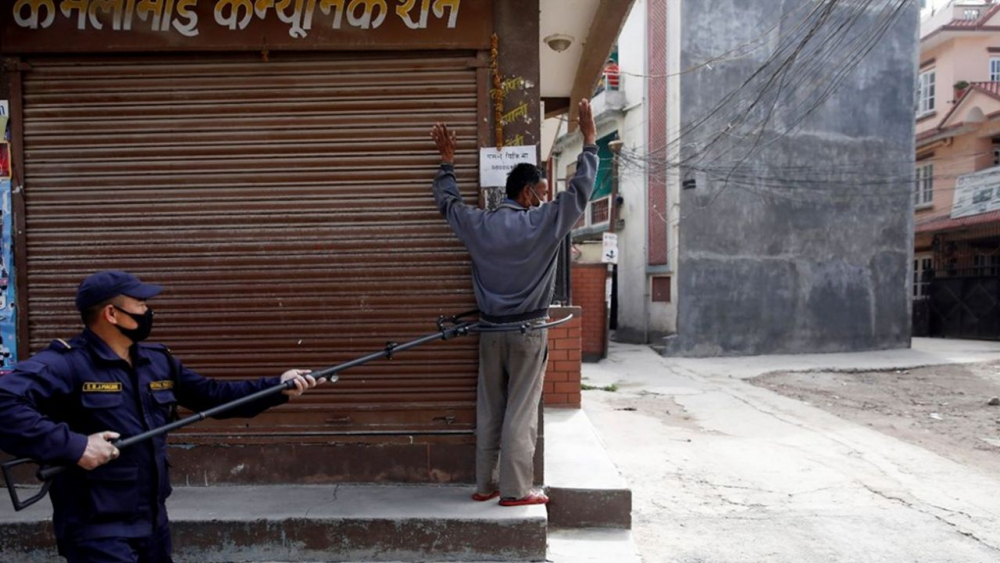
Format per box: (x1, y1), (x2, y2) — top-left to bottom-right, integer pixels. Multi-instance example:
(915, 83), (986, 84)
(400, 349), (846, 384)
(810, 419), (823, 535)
(0, 271), (316, 563)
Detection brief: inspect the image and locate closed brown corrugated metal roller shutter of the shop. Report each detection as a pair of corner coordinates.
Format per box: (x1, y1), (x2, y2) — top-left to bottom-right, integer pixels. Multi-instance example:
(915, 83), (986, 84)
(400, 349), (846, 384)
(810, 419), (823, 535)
(18, 53), (478, 436)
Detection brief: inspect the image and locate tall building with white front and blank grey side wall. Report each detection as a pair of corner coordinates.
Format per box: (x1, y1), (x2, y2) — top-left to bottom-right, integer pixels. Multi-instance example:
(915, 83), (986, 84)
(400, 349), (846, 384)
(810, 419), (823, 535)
(555, 0), (921, 356)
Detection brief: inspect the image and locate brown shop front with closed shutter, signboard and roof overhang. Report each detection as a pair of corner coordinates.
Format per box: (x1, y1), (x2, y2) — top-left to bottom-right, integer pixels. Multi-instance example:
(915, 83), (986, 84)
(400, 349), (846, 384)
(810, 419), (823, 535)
(0, 0), (629, 484)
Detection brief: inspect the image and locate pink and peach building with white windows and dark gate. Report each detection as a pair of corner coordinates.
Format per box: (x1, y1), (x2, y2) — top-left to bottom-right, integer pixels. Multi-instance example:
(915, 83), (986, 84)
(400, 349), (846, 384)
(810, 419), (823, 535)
(912, 2), (1000, 339)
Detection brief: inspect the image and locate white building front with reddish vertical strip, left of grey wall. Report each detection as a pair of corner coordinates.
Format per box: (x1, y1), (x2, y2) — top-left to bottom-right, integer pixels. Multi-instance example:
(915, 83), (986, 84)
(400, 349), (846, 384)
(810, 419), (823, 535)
(543, 0), (677, 343)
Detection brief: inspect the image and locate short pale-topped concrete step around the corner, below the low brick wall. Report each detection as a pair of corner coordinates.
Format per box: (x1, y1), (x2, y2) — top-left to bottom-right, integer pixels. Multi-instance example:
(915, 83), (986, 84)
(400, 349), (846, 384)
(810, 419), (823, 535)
(545, 408), (632, 529)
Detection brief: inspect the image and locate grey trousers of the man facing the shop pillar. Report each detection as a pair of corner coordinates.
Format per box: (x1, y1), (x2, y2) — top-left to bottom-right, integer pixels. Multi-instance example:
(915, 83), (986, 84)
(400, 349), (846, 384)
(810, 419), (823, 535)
(476, 330), (549, 498)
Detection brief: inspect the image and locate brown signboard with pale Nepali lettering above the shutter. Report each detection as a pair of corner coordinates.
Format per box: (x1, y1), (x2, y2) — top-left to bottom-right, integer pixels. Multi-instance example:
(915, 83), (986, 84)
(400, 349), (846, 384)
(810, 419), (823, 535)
(3, 0), (492, 52)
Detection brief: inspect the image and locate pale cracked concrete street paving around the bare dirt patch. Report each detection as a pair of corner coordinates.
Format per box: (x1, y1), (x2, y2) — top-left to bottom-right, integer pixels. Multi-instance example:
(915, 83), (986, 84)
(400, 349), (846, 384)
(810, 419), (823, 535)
(583, 339), (1000, 563)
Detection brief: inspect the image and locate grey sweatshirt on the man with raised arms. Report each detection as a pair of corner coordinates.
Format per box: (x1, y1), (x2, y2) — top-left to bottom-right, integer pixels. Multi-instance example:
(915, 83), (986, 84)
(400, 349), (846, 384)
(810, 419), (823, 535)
(434, 145), (598, 323)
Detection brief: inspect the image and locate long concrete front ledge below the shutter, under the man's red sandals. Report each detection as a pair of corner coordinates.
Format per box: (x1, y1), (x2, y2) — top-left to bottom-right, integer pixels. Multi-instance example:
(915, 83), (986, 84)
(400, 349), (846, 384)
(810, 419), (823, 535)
(0, 485), (547, 563)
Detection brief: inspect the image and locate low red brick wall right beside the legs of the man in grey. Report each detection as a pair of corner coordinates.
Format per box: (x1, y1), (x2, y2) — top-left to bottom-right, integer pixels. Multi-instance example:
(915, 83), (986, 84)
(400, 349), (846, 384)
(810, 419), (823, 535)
(542, 307), (583, 409)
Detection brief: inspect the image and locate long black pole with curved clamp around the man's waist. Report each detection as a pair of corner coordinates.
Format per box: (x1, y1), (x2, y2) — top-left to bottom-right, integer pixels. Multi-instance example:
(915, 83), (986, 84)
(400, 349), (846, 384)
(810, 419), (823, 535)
(0, 311), (573, 511)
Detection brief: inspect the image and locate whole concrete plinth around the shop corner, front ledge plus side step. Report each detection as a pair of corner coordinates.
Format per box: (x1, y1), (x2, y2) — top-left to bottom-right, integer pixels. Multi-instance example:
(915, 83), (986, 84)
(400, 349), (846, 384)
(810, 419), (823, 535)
(0, 409), (635, 563)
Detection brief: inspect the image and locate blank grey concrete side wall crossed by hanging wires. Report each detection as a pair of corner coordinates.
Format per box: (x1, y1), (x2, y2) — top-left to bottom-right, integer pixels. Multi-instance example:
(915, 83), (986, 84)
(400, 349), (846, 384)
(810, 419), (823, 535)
(664, 0), (918, 356)
